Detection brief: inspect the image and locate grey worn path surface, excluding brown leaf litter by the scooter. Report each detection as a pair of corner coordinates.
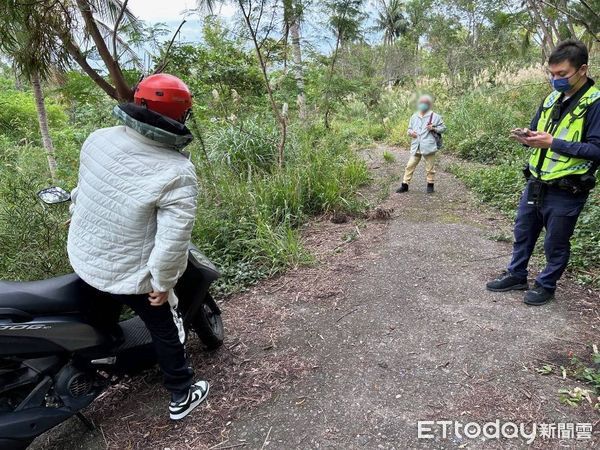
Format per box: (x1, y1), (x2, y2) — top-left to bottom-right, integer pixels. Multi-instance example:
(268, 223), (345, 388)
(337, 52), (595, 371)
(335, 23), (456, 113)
(219, 149), (600, 449)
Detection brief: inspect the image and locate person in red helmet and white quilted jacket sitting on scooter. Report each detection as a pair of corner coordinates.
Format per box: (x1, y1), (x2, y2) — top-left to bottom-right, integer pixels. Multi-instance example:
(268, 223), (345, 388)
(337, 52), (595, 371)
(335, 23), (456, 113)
(68, 74), (209, 420)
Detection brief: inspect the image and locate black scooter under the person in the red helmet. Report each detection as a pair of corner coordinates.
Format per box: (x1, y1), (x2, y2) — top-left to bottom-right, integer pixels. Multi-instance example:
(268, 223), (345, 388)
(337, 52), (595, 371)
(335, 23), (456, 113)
(0, 187), (224, 450)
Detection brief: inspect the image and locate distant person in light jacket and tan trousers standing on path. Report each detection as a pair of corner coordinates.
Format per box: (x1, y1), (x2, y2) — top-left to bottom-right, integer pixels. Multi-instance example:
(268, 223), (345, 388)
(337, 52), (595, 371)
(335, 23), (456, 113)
(396, 95), (446, 194)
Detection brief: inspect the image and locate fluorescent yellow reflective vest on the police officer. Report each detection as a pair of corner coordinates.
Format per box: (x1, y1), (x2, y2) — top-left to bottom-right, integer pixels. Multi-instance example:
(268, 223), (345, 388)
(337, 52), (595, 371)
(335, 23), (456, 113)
(529, 86), (600, 181)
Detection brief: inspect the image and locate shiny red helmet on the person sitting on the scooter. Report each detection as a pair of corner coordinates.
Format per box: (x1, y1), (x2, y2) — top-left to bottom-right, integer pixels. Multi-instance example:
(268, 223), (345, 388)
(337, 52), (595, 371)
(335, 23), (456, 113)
(133, 73), (192, 123)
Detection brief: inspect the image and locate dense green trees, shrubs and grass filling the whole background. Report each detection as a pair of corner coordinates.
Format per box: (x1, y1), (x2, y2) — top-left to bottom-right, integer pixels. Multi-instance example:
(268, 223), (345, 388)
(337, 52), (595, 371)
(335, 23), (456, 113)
(0, 0), (600, 290)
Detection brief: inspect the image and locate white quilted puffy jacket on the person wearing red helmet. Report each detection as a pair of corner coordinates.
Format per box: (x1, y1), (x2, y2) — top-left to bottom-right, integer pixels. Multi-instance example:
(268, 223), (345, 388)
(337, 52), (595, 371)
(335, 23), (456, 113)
(67, 119), (198, 294)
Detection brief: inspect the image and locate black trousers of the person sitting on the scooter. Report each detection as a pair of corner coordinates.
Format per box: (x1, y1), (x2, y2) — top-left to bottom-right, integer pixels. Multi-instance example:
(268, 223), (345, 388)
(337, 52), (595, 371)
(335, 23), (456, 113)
(85, 288), (194, 396)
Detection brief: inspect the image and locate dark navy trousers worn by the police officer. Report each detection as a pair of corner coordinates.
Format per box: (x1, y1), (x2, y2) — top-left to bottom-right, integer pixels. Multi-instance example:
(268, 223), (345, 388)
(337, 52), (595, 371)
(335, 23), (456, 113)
(508, 182), (588, 291)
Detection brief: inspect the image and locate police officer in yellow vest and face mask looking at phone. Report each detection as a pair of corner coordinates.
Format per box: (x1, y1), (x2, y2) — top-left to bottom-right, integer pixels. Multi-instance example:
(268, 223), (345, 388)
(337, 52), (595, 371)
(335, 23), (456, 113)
(486, 40), (600, 306)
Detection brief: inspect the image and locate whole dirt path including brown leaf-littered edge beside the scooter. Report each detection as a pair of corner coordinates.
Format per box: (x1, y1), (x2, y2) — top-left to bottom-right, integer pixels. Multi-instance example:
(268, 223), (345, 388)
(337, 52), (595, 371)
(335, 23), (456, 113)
(35, 147), (600, 450)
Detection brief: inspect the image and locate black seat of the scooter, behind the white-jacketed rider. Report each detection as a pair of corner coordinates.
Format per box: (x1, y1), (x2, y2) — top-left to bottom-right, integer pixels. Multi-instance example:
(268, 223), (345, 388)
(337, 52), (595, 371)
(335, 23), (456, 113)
(0, 273), (93, 316)
